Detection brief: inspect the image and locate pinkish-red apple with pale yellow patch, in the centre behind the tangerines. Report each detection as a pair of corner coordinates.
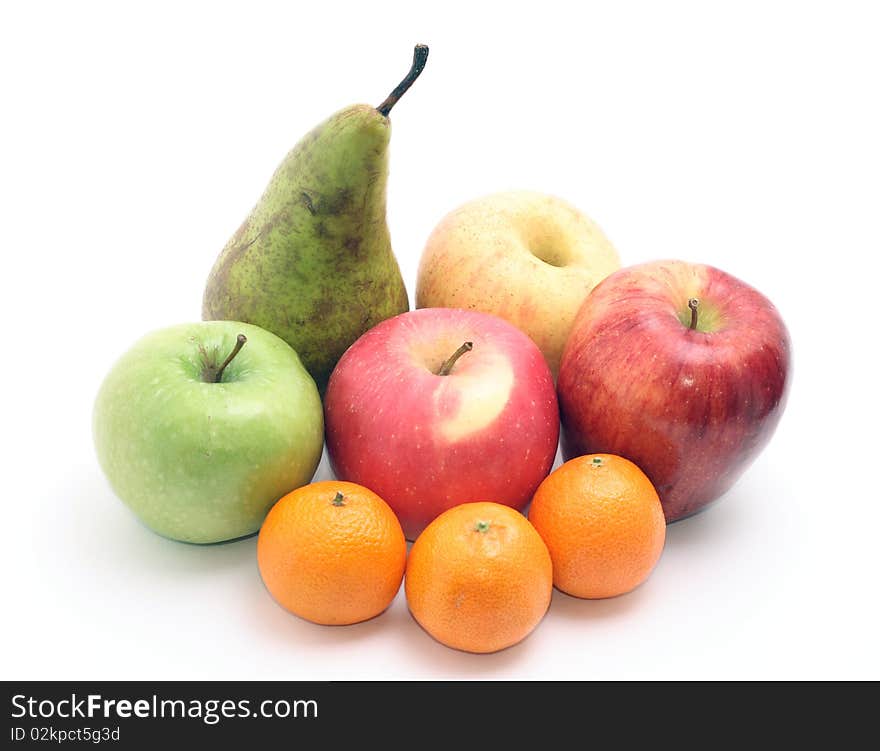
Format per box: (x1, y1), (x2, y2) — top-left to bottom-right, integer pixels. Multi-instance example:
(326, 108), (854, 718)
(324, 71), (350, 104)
(324, 308), (559, 539)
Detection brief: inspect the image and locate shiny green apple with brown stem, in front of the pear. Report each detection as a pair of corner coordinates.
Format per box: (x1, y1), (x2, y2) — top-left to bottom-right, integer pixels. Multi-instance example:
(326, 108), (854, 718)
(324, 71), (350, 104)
(93, 321), (324, 543)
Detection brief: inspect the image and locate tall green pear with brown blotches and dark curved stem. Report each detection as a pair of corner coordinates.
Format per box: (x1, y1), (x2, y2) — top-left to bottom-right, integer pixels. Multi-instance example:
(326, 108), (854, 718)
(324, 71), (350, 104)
(202, 45), (428, 392)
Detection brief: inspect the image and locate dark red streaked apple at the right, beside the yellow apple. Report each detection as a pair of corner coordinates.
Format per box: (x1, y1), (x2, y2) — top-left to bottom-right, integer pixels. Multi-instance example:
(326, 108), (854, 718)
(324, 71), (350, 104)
(558, 261), (791, 522)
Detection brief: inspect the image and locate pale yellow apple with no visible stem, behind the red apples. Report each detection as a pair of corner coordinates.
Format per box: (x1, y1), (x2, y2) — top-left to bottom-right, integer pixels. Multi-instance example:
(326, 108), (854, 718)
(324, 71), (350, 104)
(416, 191), (620, 377)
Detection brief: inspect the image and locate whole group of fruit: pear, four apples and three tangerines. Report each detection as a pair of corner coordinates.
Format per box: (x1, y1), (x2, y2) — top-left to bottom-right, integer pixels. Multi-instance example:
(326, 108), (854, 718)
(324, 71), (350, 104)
(94, 45), (790, 652)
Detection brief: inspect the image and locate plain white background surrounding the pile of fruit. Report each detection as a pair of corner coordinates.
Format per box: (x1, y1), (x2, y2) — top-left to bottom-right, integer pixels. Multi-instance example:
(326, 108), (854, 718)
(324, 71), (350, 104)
(0, 0), (880, 679)
